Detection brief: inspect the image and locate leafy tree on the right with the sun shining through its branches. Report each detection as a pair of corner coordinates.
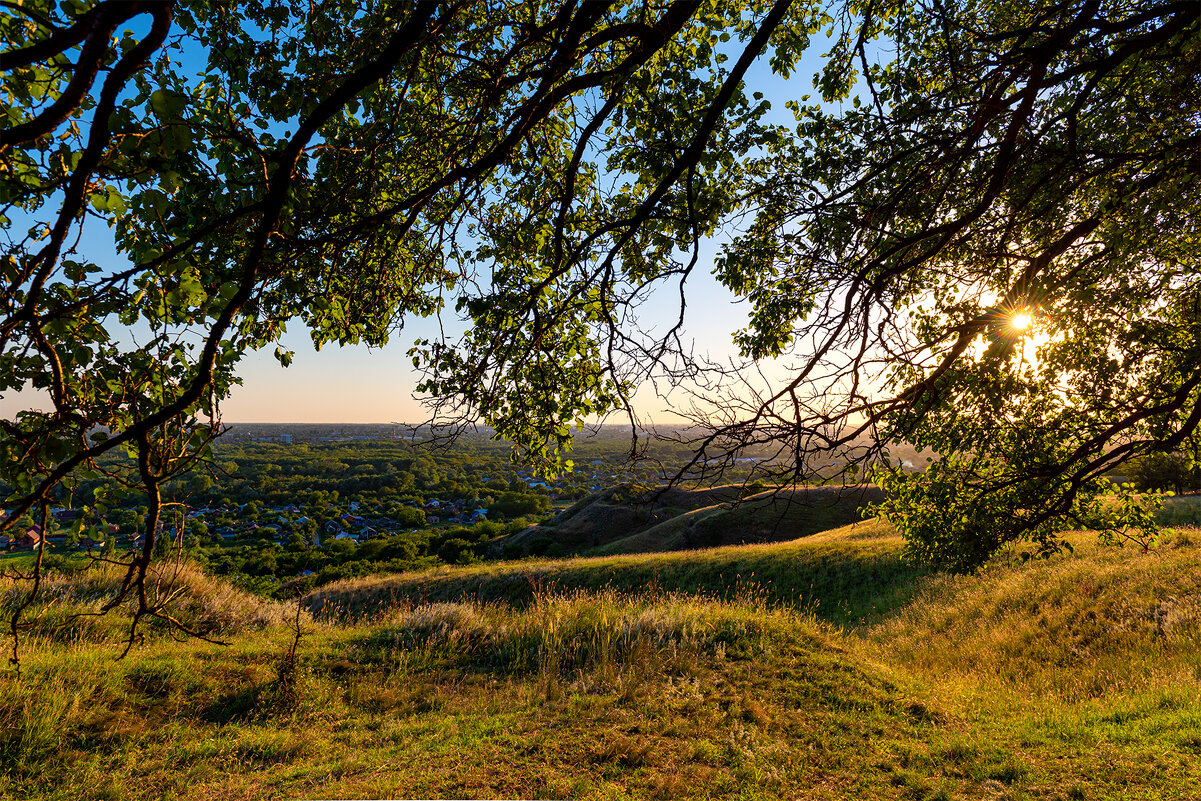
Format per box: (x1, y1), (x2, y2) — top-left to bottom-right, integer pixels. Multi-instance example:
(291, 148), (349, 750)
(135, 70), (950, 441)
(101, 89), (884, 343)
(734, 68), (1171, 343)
(672, 0), (1201, 569)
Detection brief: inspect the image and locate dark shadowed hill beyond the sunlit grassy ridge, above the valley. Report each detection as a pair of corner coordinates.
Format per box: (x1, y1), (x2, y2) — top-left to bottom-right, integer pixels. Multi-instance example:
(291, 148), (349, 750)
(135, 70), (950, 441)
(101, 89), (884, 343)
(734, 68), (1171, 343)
(498, 484), (882, 555)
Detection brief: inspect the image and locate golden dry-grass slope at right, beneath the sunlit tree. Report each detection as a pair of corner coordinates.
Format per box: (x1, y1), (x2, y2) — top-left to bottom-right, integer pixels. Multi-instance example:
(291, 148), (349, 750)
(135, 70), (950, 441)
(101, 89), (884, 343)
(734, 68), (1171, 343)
(870, 531), (1201, 700)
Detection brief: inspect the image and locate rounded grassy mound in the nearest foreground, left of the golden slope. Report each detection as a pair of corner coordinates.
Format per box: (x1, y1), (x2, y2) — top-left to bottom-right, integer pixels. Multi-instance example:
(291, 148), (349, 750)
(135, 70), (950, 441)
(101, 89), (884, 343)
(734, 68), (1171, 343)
(0, 583), (965, 799)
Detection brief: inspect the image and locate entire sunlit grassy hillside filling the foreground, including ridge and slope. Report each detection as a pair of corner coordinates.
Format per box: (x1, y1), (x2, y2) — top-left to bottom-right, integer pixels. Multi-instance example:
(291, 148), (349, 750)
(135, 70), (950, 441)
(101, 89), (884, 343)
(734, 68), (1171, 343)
(0, 521), (1201, 800)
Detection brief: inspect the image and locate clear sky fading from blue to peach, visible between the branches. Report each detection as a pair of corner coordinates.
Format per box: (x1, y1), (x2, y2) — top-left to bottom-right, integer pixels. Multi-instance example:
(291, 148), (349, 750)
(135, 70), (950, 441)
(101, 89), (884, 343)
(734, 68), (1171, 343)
(0, 14), (840, 424)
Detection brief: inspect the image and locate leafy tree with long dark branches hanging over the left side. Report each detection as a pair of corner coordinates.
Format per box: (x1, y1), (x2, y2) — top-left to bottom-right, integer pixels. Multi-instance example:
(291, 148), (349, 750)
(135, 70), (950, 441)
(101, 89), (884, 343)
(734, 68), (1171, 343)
(7, 0), (812, 641)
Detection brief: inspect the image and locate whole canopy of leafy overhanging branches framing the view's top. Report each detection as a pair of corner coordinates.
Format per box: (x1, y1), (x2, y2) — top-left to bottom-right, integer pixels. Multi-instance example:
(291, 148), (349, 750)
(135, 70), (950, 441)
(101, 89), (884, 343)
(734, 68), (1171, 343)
(0, 0), (1201, 614)
